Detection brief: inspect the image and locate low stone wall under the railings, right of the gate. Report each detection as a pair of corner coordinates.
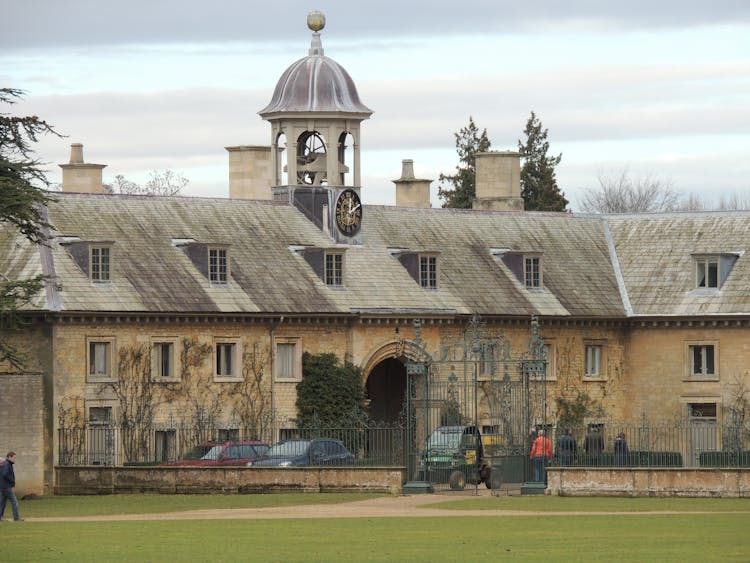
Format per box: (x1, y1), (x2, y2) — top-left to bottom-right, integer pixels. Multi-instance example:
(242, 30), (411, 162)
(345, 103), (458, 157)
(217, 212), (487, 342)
(547, 467), (750, 498)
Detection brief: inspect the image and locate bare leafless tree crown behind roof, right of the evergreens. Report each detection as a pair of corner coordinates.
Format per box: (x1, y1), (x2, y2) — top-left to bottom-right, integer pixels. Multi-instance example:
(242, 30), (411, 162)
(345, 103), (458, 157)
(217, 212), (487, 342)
(580, 168), (680, 213)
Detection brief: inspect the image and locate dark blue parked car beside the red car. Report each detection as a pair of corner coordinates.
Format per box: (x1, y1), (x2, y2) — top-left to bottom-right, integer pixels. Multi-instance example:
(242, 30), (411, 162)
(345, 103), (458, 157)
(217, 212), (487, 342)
(248, 438), (354, 467)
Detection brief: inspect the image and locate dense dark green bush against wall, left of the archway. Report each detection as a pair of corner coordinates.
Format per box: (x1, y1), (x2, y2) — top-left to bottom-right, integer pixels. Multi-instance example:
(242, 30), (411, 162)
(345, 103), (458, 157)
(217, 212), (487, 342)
(297, 352), (367, 428)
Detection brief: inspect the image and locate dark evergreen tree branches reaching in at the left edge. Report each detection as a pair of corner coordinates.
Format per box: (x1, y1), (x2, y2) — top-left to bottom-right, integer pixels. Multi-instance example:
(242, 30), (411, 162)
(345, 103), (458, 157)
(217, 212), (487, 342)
(0, 88), (61, 369)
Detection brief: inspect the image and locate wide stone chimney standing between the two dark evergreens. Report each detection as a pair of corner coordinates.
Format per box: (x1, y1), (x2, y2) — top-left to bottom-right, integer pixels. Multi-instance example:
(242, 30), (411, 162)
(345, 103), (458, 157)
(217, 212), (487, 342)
(472, 151), (523, 211)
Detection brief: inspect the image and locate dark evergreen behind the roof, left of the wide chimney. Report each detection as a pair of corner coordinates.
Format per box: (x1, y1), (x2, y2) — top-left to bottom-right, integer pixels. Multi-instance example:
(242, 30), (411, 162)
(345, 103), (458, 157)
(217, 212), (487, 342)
(438, 116), (491, 209)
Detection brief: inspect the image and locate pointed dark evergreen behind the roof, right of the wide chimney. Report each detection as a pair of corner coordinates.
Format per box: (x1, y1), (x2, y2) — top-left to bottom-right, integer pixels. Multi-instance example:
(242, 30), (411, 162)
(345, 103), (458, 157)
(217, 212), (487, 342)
(518, 111), (568, 211)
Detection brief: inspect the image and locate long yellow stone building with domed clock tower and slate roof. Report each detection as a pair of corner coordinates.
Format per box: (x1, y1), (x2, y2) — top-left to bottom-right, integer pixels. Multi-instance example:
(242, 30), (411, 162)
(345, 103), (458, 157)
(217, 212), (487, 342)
(0, 9), (750, 492)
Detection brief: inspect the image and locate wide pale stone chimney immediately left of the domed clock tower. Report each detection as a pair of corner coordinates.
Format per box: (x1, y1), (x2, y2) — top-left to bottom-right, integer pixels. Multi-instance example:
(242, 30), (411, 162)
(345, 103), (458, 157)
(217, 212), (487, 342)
(231, 146), (273, 199)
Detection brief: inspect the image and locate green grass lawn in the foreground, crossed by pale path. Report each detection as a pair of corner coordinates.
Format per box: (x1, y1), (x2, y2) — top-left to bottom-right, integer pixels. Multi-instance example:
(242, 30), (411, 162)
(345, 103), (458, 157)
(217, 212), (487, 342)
(5, 495), (750, 563)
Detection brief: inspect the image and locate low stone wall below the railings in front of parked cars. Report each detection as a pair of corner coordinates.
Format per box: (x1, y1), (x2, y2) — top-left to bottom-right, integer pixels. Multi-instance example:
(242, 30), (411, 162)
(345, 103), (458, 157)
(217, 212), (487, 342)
(55, 466), (405, 495)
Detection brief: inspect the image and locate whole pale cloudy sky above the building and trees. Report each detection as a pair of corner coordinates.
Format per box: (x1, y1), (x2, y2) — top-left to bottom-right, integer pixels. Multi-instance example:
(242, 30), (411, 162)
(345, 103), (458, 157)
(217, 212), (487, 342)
(0, 0), (750, 209)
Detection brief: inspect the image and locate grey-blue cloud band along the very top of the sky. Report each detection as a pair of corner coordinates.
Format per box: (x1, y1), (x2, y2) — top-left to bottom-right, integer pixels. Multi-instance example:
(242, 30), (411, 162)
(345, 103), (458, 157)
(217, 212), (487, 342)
(5, 0), (750, 50)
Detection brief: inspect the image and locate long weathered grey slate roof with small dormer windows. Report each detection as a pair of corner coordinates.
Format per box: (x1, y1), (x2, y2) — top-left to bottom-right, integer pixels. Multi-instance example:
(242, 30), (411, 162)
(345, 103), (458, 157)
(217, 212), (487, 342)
(0, 193), (750, 318)
